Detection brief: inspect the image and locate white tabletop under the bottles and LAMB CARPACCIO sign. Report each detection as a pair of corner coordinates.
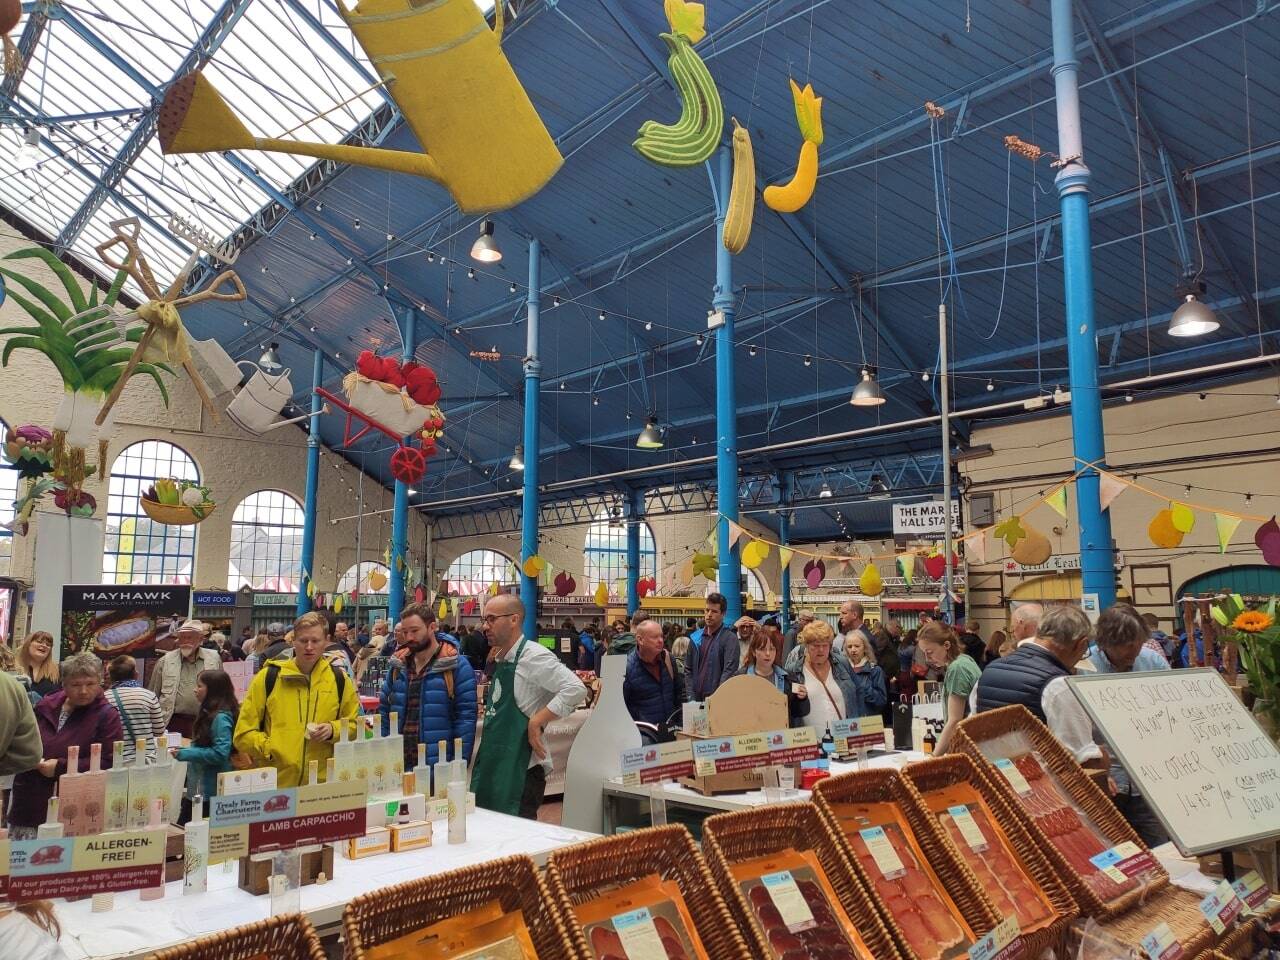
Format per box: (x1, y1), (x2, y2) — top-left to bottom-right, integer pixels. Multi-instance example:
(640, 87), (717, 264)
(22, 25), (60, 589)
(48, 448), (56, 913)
(55, 810), (593, 960)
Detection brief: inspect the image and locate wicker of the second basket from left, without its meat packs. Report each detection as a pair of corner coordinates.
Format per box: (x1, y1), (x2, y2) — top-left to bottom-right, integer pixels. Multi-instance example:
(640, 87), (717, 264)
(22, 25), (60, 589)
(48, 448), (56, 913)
(342, 856), (579, 960)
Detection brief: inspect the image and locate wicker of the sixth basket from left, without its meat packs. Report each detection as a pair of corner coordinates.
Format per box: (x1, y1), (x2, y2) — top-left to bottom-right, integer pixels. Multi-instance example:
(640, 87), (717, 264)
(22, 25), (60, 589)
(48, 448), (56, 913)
(904, 754), (1078, 957)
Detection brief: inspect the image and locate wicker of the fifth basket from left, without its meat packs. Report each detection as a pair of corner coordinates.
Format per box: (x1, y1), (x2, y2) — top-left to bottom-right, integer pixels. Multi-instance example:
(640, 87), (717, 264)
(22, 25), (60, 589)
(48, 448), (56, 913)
(813, 769), (1001, 960)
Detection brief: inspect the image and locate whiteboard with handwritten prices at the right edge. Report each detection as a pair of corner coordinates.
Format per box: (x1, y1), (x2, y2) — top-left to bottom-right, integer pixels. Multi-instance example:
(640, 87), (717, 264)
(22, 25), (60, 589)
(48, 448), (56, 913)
(1066, 669), (1280, 854)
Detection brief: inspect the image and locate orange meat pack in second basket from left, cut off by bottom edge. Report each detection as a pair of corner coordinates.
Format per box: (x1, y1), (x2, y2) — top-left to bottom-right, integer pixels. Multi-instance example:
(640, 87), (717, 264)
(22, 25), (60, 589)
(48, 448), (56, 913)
(365, 900), (538, 960)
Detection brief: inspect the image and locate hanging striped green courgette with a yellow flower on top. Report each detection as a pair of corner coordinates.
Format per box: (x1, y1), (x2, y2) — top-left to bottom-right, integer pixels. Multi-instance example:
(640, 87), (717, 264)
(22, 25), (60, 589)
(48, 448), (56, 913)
(632, 0), (724, 166)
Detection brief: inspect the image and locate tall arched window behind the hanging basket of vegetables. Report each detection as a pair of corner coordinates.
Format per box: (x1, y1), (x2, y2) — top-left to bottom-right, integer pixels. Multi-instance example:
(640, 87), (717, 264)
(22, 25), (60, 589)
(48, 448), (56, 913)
(102, 440), (200, 584)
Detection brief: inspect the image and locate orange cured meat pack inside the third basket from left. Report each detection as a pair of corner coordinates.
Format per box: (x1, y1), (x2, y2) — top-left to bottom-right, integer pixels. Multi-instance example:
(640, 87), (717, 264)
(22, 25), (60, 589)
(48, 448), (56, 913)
(573, 873), (708, 960)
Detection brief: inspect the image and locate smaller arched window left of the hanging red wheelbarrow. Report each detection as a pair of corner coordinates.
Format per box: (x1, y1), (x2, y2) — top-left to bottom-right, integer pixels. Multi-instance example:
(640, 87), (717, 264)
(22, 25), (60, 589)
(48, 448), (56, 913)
(227, 490), (303, 594)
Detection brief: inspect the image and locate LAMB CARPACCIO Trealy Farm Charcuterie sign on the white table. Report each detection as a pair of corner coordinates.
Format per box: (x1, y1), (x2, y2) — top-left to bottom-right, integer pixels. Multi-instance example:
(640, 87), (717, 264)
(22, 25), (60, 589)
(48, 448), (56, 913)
(209, 780), (369, 864)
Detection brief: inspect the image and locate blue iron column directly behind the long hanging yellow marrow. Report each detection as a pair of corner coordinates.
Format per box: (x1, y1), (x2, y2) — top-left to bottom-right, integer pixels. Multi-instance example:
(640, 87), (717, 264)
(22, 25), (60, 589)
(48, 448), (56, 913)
(712, 146), (742, 623)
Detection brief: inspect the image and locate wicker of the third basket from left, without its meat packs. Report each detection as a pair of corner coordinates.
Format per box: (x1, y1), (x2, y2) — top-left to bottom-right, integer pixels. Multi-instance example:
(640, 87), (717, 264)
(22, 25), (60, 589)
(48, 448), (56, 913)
(547, 827), (754, 960)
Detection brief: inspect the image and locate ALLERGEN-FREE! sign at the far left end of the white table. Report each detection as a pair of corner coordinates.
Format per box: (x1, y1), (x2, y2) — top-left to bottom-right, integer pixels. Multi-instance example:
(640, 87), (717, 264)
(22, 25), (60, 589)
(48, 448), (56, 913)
(8, 827), (166, 900)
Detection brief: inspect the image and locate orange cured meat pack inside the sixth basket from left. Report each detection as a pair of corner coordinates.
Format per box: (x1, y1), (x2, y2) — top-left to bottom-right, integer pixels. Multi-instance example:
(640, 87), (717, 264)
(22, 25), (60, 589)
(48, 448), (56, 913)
(924, 783), (1056, 933)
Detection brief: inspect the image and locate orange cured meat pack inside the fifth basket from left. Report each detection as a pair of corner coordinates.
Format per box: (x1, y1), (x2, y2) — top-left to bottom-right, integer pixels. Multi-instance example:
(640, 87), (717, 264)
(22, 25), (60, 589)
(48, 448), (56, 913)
(831, 803), (978, 960)
